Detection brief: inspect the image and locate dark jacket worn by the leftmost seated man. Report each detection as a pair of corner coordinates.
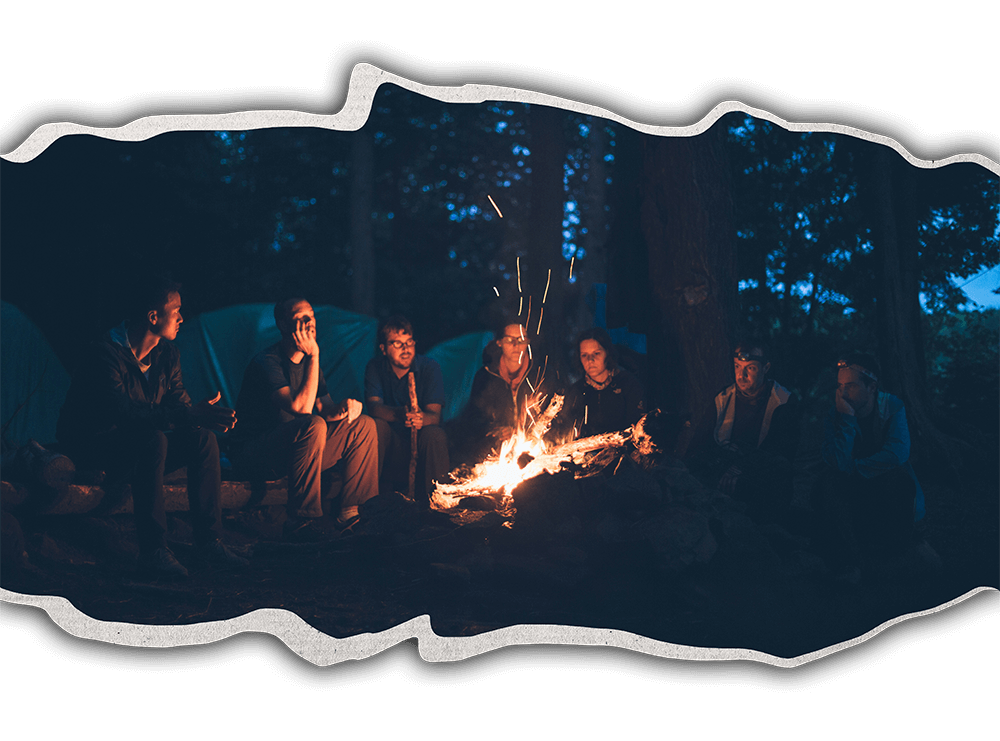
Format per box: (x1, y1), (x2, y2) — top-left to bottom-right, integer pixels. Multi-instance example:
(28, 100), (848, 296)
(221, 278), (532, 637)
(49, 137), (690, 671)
(56, 325), (191, 446)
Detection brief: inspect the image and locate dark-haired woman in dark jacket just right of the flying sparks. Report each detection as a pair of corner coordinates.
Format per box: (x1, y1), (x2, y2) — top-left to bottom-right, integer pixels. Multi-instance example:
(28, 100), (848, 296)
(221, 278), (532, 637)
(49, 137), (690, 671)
(549, 327), (644, 441)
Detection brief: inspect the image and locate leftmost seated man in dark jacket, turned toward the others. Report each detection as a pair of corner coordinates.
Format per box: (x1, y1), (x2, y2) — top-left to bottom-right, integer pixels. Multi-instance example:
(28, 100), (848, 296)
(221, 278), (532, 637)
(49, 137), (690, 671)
(57, 277), (248, 576)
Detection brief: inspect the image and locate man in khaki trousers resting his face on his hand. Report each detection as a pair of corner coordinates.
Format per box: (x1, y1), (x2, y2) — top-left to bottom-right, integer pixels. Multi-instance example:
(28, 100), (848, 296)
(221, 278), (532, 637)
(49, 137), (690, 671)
(234, 298), (378, 540)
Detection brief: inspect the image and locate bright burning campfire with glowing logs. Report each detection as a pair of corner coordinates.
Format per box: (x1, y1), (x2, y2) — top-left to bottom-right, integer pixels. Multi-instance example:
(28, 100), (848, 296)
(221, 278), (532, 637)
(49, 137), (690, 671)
(431, 394), (656, 512)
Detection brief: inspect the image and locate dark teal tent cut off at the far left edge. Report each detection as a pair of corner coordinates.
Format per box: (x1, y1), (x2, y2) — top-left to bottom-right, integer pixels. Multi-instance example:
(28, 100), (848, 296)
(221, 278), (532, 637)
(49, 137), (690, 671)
(0, 301), (70, 446)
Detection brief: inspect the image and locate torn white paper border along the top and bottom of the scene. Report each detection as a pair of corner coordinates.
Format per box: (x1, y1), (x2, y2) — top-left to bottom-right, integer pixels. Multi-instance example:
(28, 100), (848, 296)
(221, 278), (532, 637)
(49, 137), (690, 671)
(0, 63), (1000, 667)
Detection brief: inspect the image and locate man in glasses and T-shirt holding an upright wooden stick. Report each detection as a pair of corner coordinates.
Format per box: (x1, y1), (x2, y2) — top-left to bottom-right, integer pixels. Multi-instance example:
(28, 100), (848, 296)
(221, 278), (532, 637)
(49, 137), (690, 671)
(365, 315), (451, 504)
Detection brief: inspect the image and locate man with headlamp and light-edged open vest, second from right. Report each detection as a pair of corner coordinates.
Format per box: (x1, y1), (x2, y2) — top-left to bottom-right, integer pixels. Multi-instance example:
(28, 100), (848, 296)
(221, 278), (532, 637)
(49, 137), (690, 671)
(689, 342), (799, 521)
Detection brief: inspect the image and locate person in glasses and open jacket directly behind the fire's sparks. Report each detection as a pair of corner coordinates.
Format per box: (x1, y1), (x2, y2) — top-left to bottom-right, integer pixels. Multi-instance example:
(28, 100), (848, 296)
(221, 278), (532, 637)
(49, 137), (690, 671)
(455, 323), (550, 463)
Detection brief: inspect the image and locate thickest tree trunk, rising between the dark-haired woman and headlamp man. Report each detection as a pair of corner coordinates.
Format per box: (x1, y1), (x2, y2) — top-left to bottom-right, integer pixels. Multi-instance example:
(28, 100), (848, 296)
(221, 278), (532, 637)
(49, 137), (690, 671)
(641, 127), (737, 440)
